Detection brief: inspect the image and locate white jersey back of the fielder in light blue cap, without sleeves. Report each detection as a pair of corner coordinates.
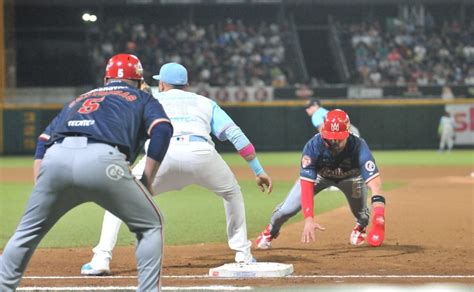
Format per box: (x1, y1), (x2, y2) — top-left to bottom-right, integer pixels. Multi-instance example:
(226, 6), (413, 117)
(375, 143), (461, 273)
(155, 89), (213, 139)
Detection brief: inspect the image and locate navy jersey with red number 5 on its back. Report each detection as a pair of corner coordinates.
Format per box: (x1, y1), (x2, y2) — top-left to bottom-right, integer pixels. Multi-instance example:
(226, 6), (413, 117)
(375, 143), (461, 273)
(40, 82), (170, 163)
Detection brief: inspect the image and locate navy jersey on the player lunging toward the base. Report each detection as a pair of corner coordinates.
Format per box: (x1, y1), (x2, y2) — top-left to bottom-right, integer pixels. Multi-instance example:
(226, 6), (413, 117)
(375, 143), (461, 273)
(300, 134), (379, 182)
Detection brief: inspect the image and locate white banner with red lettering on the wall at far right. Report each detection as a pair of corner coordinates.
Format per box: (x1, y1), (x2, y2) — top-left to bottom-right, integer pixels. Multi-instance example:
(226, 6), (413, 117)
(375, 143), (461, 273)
(446, 103), (474, 145)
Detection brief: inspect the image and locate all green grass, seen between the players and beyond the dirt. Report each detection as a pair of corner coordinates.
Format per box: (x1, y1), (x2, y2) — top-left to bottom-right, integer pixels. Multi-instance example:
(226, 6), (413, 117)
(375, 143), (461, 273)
(0, 151), (466, 248)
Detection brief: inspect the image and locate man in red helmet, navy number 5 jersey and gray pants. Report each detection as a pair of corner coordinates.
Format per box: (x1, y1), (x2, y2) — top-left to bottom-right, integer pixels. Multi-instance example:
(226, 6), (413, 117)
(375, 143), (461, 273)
(0, 54), (173, 292)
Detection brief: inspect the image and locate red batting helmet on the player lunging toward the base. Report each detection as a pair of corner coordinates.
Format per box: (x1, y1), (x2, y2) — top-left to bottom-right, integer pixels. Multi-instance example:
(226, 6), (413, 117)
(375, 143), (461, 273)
(321, 109), (350, 140)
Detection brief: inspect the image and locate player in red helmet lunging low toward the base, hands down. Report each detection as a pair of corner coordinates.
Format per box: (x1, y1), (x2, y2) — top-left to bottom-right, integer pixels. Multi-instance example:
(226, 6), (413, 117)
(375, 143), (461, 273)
(255, 109), (385, 249)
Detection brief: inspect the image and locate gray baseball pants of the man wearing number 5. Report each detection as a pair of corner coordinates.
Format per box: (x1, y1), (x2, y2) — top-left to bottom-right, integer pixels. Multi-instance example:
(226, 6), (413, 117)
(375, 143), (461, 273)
(0, 137), (163, 292)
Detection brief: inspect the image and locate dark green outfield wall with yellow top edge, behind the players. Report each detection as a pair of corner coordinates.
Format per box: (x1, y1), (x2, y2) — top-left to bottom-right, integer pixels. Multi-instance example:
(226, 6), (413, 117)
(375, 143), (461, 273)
(0, 99), (474, 155)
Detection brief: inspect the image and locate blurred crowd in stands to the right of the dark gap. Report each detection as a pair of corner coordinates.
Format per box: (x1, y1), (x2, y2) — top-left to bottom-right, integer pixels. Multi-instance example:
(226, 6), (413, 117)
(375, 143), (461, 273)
(340, 15), (474, 86)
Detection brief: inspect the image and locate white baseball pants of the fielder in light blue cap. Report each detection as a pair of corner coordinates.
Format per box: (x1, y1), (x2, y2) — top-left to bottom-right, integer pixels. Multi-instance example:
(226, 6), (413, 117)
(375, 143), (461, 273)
(92, 136), (252, 266)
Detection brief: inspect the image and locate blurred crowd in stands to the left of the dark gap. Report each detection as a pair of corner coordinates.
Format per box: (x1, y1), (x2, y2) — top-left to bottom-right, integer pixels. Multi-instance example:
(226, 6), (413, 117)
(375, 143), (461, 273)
(92, 19), (291, 86)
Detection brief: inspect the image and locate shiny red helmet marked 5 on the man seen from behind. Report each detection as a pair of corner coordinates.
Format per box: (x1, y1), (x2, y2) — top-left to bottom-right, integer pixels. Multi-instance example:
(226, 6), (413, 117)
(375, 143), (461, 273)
(105, 54), (143, 80)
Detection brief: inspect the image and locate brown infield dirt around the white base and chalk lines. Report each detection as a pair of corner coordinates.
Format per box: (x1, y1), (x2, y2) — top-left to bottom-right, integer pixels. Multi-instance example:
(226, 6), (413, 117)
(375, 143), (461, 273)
(0, 166), (474, 287)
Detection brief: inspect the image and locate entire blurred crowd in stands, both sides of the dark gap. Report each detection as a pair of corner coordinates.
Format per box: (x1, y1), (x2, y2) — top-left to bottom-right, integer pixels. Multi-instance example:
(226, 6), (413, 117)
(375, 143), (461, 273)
(92, 14), (474, 87)
